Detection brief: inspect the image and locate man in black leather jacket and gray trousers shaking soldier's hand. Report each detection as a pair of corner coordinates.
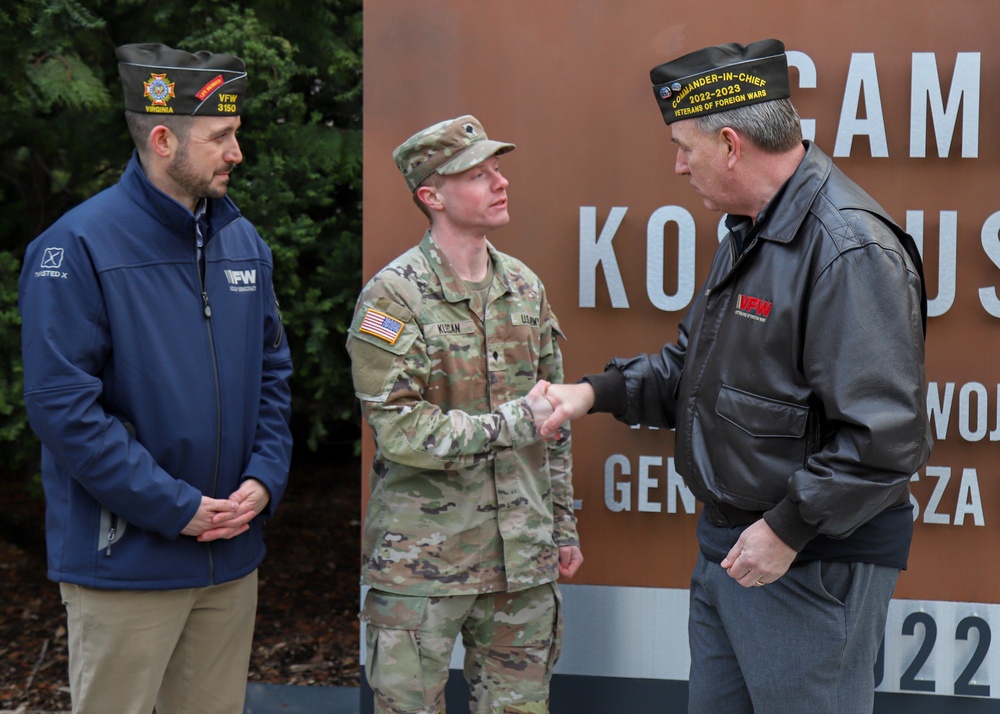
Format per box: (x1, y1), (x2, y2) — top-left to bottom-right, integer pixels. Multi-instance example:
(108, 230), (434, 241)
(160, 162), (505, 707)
(542, 40), (931, 714)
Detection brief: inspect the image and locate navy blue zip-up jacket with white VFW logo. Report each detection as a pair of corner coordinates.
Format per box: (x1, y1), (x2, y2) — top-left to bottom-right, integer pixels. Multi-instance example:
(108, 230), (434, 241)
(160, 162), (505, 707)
(19, 155), (292, 589)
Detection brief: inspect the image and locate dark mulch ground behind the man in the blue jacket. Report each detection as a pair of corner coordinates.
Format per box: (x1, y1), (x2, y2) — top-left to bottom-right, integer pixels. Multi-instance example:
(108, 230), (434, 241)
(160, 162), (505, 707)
(0, 445), (361, 712)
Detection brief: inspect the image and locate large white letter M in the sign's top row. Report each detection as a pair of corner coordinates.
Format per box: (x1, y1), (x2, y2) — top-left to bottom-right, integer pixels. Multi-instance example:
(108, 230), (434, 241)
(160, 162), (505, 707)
(910, 52), (980, 159)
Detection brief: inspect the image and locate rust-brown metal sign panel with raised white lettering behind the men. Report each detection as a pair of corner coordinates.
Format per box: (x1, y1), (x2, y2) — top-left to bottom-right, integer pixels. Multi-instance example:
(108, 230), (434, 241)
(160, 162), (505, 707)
(364, 0), (1000, 693)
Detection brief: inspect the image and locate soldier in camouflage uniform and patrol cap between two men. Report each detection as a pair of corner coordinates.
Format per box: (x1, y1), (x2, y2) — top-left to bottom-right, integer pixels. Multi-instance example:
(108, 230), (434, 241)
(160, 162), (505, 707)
(347, 116), (583, 714)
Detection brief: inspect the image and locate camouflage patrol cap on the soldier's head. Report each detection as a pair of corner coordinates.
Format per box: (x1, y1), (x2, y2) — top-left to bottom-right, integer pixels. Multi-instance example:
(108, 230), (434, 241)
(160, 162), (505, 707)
(392, 114), (514, 191)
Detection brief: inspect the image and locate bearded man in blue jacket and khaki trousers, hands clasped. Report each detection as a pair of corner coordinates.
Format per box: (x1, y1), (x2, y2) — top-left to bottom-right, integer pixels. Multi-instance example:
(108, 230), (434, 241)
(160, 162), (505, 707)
(19, 44), (292, 714)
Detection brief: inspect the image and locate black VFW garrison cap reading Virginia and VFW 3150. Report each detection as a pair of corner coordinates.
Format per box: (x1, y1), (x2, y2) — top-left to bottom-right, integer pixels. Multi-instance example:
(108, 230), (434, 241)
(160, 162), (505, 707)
(115, 43), (247, 116)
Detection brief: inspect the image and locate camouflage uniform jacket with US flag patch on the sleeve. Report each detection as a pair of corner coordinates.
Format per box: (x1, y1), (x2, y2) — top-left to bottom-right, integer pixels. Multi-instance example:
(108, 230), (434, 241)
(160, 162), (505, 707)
(347, 231), (578, 595)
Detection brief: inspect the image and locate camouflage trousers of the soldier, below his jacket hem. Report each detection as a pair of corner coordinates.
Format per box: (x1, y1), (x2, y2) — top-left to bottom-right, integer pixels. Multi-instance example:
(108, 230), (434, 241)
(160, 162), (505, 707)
(361, 583), (562, 714)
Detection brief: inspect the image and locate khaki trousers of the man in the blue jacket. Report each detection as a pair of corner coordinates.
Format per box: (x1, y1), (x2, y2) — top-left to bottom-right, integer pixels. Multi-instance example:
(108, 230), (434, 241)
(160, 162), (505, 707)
(59, 570), (257, 714)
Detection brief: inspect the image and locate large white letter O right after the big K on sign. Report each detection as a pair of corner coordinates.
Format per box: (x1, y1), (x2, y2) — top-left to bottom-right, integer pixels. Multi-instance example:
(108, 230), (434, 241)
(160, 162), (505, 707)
(646, 206), (696, 312)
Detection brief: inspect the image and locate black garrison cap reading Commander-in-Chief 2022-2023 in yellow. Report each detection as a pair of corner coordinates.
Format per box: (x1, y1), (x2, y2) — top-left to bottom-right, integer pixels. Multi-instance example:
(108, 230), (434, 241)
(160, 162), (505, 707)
(649, 40), (791, 124)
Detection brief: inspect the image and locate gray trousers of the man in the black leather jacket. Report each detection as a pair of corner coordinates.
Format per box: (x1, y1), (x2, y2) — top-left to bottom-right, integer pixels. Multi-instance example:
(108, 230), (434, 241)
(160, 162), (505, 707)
(688, 555), (899, 714)
